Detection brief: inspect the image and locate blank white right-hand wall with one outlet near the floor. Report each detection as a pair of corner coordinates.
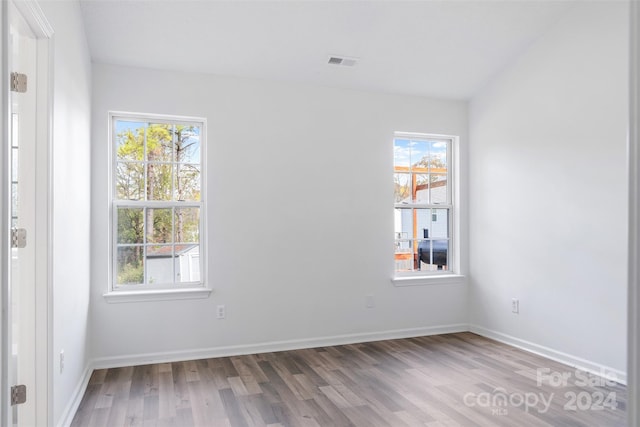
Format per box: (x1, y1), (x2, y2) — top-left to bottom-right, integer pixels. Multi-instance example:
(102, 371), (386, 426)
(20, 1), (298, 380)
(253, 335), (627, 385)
(469, 2), (628, 378)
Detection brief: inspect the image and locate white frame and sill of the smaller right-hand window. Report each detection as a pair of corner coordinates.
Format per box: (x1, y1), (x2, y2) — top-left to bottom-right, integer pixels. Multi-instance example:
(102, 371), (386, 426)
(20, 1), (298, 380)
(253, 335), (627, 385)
(391, 131), (465, 286)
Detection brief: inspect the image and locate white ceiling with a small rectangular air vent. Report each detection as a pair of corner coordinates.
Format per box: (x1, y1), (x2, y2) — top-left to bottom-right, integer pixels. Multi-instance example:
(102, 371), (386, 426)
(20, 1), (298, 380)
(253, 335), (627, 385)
(81, 0), (574, 99)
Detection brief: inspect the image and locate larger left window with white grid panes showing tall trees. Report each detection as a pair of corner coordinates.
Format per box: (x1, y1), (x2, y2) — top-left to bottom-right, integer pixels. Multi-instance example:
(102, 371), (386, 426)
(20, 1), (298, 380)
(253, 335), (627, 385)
(111, 113), (205, 291)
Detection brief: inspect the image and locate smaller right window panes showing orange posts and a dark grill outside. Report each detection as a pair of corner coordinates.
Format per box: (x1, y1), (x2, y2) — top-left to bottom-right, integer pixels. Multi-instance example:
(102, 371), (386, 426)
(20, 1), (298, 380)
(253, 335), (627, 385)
(393, 133), (454, 276)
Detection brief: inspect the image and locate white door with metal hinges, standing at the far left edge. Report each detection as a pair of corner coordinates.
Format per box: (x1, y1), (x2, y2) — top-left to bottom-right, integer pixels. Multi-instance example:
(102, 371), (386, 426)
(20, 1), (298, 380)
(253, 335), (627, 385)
(0, 2), (42, 426)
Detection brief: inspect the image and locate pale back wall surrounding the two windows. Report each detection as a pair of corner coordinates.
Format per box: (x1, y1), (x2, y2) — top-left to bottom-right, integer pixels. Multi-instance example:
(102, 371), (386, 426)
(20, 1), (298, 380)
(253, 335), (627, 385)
(91, 64), (468, 364)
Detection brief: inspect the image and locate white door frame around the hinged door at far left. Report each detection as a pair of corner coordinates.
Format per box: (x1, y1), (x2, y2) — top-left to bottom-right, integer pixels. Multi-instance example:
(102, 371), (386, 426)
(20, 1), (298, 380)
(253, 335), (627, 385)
(0, 0), (54, 425)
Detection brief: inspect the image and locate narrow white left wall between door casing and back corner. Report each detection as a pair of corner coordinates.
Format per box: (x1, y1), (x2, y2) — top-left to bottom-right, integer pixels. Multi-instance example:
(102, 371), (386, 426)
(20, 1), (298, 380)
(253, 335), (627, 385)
(41, 1), (91, 424)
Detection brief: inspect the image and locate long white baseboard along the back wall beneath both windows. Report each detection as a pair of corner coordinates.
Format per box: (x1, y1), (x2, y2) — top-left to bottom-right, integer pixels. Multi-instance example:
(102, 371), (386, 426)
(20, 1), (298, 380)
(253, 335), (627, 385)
(92, 323), (469, 369)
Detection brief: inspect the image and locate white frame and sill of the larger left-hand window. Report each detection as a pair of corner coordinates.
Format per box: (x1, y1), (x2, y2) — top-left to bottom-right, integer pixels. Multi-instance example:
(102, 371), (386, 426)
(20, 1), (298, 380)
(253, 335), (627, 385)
(103, 111), (213, 302)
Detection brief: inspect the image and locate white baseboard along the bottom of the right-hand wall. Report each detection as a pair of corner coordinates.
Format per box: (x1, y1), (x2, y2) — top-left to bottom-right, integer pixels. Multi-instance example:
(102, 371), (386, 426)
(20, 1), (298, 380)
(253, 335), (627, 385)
(469, 325), (627, 385)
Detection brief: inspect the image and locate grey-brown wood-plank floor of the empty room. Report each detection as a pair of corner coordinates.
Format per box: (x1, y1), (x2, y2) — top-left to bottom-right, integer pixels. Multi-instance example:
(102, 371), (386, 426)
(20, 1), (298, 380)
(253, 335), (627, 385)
(72, 333), (627, 427)
